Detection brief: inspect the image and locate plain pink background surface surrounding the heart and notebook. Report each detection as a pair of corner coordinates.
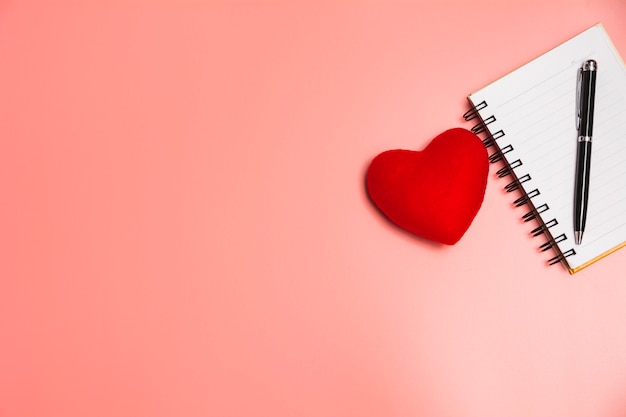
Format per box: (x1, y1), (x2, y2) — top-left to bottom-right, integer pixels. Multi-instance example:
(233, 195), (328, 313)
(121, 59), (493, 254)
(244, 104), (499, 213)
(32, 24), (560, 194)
(0, 0), (626, 417)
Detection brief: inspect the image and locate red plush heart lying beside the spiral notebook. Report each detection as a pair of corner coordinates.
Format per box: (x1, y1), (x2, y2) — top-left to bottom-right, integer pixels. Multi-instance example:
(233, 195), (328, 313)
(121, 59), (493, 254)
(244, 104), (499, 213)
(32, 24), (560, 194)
(367, 128), (489, 245)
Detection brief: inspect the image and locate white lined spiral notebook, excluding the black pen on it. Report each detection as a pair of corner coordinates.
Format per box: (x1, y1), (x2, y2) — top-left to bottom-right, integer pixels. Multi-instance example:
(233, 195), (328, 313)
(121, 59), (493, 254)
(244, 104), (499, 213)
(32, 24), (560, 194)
(464, 24), (626, 274)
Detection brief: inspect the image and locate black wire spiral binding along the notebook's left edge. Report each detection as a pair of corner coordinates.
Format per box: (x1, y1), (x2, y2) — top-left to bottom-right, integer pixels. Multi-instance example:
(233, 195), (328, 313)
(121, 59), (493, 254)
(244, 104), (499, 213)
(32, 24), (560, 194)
(463, 101), (576, 265)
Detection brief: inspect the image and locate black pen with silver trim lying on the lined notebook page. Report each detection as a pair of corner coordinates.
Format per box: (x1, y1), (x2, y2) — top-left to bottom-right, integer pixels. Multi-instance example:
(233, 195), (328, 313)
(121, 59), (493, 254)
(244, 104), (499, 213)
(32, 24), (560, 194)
(574, 59), (598, 245)
